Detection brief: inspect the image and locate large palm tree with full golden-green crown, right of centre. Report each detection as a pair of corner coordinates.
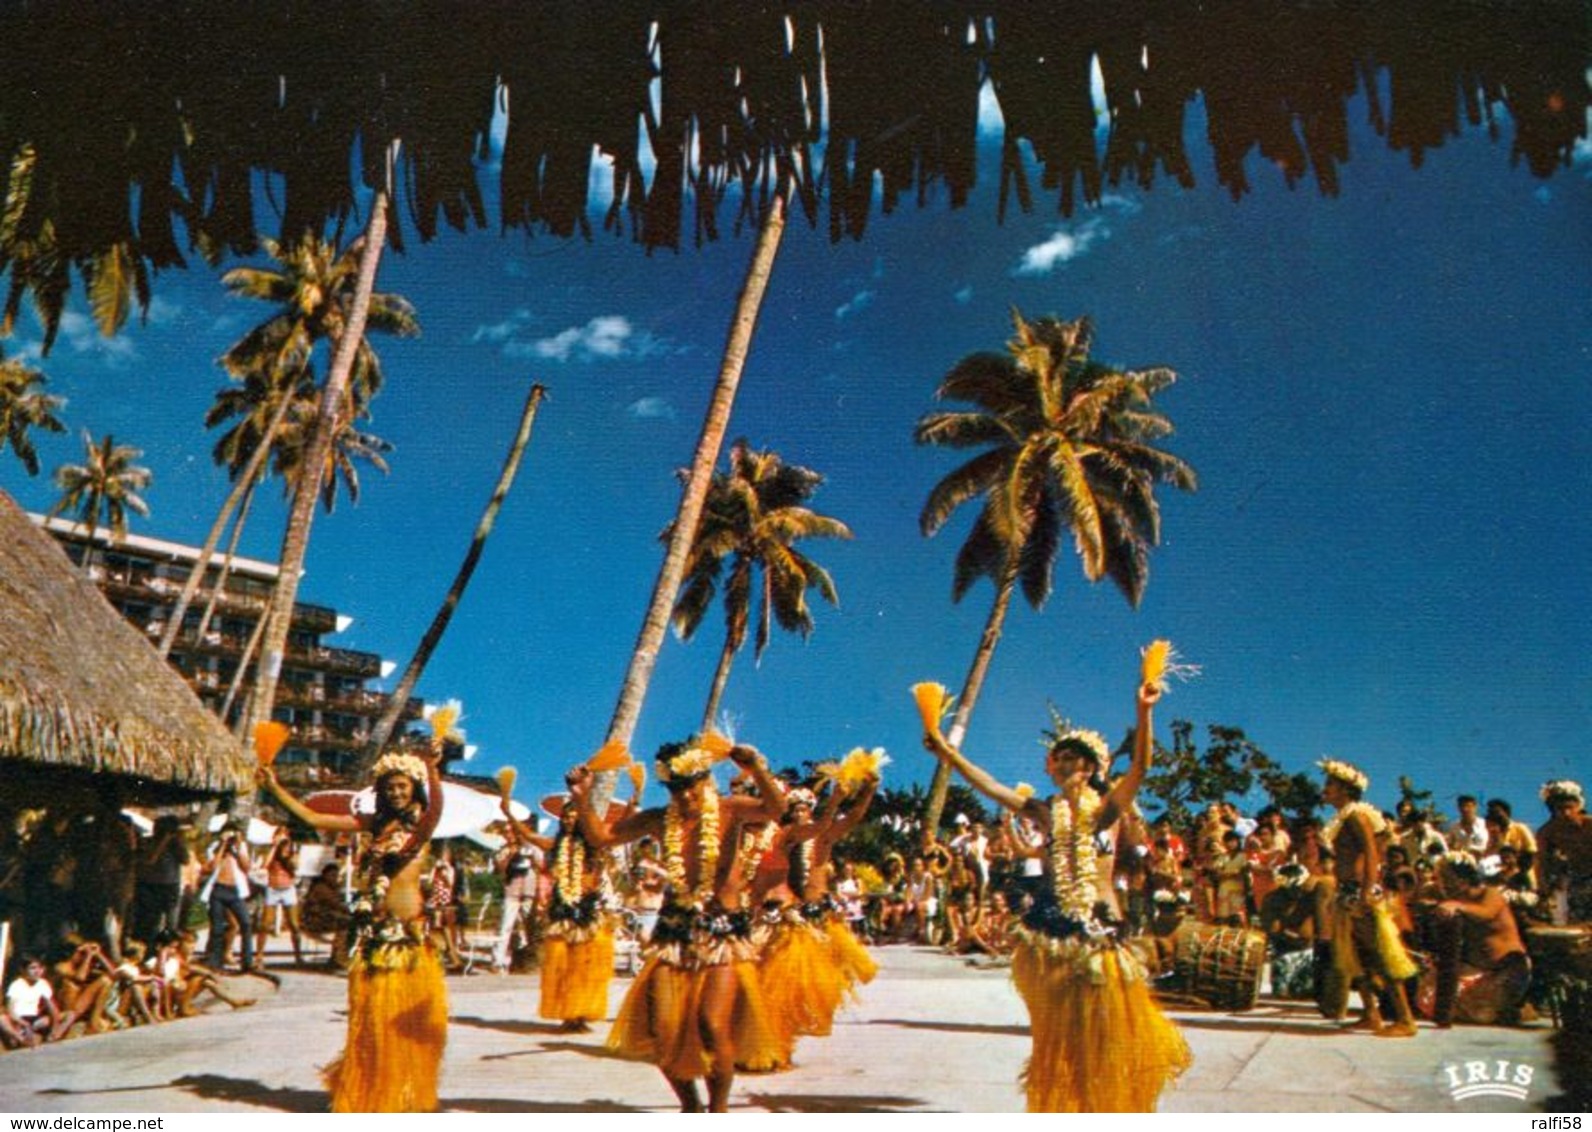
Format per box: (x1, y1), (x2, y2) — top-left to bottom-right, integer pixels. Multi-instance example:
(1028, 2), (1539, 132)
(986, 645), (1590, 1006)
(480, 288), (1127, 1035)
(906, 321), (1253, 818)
(914, 310), (1197, 837)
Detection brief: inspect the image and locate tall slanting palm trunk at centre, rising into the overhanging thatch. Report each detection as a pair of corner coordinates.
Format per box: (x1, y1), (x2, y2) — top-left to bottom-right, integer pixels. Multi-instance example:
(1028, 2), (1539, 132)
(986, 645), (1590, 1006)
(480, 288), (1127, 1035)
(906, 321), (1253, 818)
(594, 186), (785, 770)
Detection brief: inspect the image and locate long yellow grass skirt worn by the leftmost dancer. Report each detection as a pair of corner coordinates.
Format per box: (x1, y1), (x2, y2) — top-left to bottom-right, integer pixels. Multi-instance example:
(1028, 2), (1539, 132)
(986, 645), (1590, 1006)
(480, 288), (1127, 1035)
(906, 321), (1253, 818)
(322, 944), (447, 1113)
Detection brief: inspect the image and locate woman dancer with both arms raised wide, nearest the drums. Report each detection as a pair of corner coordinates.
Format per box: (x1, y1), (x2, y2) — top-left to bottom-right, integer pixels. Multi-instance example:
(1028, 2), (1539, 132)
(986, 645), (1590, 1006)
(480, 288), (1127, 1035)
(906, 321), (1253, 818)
(923, 685), (1191, 1113)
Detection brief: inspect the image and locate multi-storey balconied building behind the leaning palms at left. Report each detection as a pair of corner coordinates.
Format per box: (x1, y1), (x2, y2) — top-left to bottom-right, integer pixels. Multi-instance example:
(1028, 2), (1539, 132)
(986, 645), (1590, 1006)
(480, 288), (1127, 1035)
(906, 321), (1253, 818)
(29, 514), (422, 785)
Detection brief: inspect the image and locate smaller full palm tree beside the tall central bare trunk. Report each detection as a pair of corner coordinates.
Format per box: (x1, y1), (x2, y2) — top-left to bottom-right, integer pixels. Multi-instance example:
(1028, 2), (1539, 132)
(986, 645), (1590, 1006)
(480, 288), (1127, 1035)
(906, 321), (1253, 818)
(665, 439), (852, 731)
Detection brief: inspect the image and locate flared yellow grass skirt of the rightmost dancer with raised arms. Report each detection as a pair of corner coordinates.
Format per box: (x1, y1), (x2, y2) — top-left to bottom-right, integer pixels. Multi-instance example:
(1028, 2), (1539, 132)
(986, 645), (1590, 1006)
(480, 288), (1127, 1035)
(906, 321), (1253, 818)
(1011, 936), (1192, 1113)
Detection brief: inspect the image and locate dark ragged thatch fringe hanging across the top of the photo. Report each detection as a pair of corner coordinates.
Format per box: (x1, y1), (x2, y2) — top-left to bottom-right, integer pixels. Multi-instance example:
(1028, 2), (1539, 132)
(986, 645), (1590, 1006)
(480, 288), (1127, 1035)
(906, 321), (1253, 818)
(0, 0), (1589, 306)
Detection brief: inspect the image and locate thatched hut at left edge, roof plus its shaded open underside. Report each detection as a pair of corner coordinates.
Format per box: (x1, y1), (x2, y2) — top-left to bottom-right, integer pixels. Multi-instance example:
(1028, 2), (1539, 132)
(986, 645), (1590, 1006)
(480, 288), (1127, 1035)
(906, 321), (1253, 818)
(0, 492), (253, 947)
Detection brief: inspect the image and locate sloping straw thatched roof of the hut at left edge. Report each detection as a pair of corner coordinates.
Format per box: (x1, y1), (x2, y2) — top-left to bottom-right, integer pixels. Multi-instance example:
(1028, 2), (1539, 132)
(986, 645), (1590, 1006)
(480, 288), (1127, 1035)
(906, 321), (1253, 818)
(0, 492), (253, 793)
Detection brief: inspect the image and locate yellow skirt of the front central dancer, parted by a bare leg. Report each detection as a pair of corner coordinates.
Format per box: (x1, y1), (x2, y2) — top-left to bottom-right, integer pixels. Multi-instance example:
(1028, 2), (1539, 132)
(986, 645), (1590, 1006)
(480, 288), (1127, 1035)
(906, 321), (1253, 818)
(608, 957), (778, 1081)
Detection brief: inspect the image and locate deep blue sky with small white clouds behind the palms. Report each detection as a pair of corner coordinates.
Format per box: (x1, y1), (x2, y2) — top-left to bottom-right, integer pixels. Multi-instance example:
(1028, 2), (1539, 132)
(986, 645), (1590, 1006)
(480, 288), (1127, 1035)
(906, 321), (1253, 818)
(0, 81), (1592, 823)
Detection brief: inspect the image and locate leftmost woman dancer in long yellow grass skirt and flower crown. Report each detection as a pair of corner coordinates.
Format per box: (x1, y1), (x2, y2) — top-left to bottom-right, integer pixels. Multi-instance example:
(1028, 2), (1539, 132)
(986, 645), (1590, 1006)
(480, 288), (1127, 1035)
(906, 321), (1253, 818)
(256, 744), (447, 1113)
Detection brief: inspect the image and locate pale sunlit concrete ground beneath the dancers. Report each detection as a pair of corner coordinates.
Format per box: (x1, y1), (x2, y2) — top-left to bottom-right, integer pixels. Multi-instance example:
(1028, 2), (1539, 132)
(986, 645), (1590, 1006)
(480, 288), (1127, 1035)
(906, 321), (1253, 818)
(0, 946), (1557, 1113)
